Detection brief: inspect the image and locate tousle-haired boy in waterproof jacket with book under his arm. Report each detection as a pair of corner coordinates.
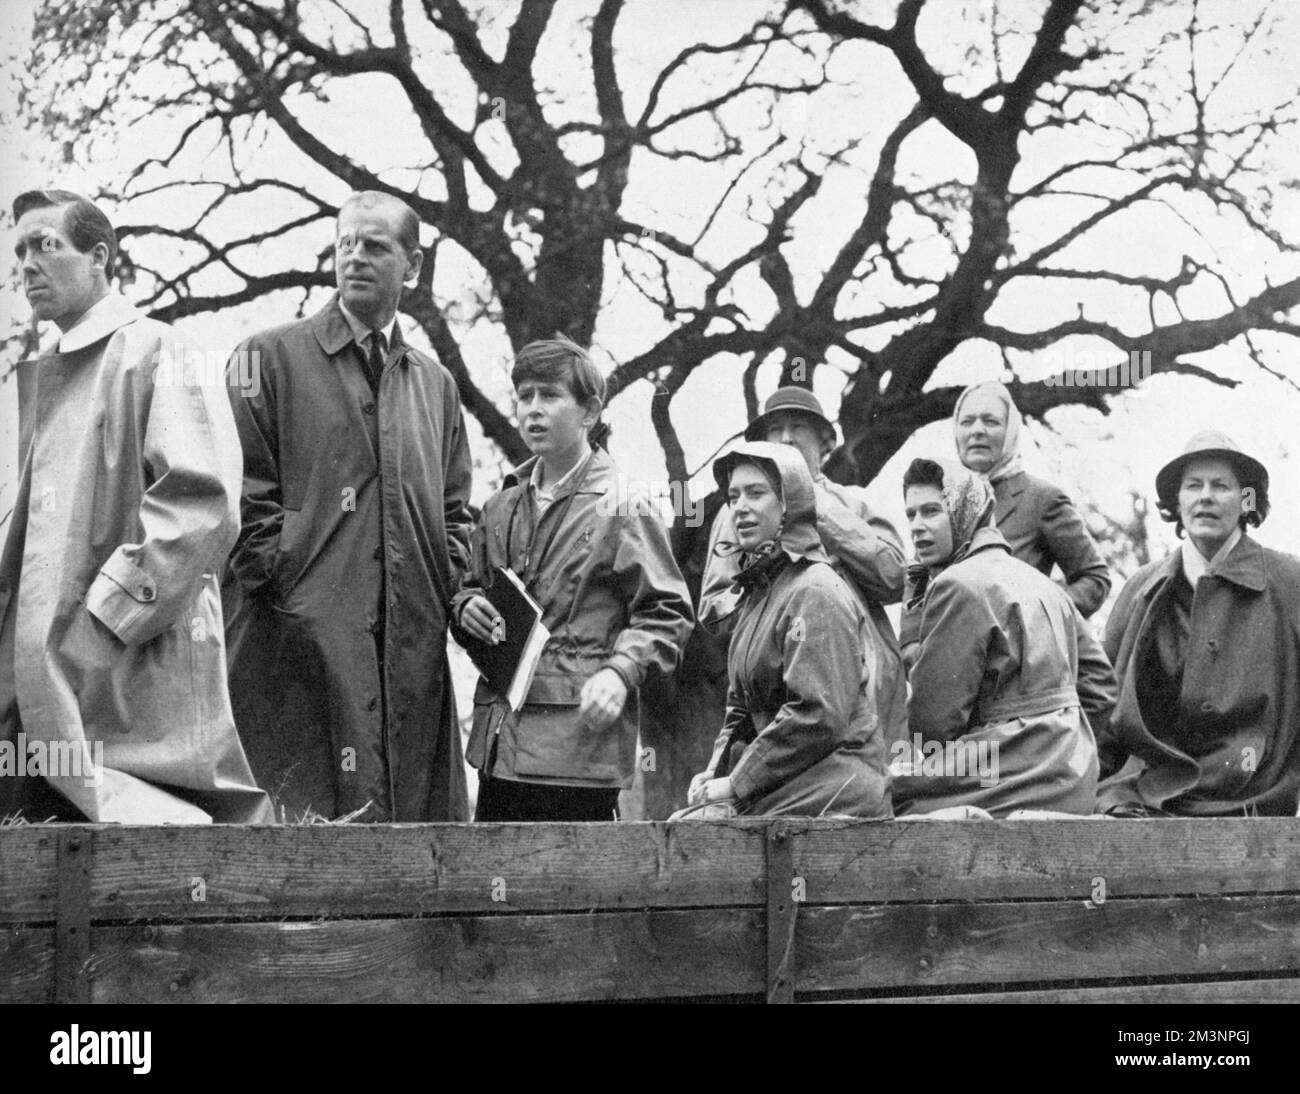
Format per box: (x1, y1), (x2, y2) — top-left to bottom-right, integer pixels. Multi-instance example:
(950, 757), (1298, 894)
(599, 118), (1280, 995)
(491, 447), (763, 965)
(452, 337), (694, 821)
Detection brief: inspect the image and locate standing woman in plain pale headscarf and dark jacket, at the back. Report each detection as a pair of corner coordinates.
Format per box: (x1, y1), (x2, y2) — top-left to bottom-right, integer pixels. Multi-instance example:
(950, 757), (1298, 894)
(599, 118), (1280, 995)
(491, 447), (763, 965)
(901, 381), (1110, 664)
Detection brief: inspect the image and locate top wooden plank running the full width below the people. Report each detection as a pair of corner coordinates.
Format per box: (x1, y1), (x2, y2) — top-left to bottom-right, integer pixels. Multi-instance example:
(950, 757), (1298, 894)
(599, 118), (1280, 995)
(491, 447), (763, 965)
(0, 819), (1300, 922)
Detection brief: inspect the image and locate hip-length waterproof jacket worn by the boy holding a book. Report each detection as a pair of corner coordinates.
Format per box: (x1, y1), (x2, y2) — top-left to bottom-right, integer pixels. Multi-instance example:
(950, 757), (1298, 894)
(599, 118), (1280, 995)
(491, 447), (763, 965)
(452, 448), (694, 789)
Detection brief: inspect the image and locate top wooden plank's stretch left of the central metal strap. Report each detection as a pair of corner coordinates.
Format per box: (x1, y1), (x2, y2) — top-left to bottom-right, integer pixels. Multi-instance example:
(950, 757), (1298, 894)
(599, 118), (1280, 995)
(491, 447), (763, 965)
(0, 824), (764, 922)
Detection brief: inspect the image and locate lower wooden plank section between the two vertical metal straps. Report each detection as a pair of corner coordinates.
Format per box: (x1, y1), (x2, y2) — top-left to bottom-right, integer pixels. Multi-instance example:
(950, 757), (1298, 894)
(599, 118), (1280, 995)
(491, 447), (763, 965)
(81, 908), (764, 1003)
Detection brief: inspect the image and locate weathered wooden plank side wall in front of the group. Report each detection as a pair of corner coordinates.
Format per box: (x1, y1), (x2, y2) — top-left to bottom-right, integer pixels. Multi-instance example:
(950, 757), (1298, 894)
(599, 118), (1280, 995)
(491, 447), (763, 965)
(0, 820), (1300, 1002)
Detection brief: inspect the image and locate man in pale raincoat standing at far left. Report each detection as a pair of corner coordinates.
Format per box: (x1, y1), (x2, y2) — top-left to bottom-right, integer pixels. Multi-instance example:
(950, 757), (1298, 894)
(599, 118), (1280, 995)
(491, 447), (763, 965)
(0, 190), (270, 824)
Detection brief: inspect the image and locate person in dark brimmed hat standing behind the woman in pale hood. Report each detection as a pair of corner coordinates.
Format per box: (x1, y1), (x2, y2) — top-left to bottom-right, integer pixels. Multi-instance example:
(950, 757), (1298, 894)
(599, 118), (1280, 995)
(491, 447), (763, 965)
(698, 386), (907, 741)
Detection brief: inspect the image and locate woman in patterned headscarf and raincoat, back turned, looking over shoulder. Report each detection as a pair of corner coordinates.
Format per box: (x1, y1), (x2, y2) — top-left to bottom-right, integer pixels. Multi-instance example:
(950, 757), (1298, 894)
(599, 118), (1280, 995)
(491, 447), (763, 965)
(892, 460), (1117, 816)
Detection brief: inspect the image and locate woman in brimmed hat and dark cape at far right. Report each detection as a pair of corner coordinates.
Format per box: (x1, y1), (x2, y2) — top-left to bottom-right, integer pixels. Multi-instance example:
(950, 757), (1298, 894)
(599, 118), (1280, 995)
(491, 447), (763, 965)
(1097, 430), (1300, 816)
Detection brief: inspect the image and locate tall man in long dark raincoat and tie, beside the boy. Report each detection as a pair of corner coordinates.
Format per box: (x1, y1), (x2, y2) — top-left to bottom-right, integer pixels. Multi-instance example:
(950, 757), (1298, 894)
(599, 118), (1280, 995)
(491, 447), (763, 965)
(225, 192), (472, 821)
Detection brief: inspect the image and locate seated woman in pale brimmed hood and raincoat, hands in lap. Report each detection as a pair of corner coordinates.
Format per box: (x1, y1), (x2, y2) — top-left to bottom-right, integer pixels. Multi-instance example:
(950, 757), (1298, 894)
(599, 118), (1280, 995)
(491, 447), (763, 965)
(679, 442), (891, 819)
